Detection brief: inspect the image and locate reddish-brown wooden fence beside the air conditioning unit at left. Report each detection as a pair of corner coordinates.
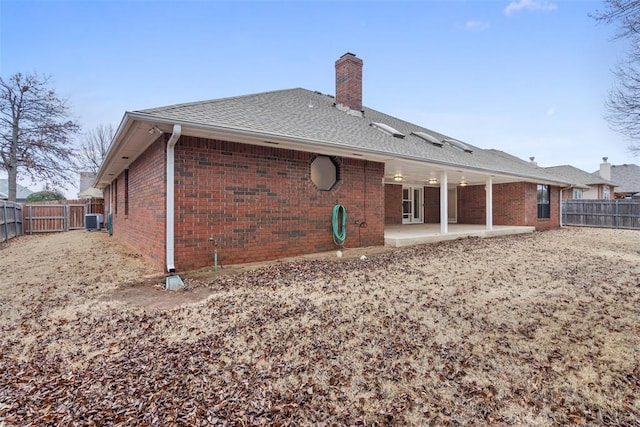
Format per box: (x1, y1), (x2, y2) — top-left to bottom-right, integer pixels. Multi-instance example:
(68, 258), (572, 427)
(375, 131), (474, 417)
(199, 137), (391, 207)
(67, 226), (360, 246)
(23, 198), (104, 234)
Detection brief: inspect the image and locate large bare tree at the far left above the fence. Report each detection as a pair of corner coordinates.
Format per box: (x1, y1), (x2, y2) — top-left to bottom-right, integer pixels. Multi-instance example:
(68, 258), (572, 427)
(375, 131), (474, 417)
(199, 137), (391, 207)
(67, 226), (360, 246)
(0, 73), (80, 200)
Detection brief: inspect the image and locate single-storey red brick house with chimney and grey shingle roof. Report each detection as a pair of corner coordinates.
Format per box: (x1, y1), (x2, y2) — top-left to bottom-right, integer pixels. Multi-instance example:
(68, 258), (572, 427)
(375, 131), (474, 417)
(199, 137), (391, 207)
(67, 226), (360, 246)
(94, 53), (568, 272)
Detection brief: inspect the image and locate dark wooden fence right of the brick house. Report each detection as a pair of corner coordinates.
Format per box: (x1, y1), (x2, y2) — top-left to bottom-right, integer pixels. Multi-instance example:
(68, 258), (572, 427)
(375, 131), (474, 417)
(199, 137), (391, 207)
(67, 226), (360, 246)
(562, 200), (640, 230)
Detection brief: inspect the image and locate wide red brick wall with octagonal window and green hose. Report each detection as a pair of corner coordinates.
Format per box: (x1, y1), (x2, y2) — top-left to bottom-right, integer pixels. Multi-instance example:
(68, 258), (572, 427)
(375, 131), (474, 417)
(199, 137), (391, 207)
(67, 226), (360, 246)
(168, 137), (384, 270)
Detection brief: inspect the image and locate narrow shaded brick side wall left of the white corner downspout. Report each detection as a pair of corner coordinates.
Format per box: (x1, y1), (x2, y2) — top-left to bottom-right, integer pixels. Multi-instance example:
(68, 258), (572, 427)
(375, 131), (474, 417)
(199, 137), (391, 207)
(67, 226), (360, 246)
(105, 136), (166, 269)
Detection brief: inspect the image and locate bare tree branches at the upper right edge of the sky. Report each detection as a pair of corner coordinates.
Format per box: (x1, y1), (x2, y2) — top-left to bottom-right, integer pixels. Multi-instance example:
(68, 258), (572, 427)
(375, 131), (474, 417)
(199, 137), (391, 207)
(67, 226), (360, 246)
(594, 0), (640, 156)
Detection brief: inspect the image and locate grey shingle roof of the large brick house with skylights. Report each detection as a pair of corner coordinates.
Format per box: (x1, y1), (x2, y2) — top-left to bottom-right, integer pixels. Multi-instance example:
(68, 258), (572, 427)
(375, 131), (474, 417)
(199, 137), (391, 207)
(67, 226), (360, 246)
(135, 88), (564, 183)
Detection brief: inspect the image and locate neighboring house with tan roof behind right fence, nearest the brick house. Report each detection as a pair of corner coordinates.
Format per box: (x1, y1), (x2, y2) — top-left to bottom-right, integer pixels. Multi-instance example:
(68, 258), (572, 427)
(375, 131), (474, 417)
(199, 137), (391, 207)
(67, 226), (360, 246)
(545, 165), (615, 200)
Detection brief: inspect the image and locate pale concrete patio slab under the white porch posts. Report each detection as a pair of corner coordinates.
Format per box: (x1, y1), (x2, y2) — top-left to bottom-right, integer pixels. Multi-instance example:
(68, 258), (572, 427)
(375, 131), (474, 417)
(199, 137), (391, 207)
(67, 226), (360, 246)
(384, 224), (535, 248)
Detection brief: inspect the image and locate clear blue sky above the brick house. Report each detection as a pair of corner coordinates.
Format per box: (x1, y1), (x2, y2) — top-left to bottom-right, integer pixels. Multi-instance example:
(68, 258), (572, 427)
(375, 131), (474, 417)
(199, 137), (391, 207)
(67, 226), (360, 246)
(0, 0), (638, 194)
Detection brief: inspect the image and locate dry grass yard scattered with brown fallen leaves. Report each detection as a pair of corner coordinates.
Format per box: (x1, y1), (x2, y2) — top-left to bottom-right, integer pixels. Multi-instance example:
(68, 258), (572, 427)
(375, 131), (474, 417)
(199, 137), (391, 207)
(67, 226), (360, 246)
(0, 228), (640, 426)
